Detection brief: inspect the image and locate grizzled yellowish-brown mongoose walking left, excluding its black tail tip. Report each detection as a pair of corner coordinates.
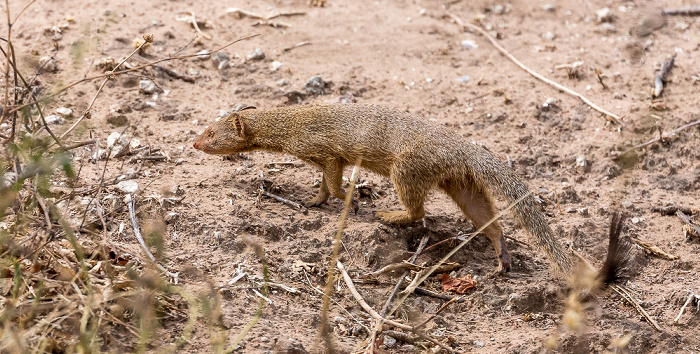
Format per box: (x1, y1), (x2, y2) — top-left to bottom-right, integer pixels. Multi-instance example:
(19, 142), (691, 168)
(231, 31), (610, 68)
(194, 104), (574, 274)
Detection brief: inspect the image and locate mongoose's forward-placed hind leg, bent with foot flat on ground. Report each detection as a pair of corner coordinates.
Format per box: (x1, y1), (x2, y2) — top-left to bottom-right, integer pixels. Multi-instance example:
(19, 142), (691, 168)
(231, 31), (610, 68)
(375, 169), (430, 224)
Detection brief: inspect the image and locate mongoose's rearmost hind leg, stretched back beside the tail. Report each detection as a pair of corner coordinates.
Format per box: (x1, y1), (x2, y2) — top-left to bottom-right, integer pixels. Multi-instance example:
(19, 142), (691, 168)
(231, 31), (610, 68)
(440, 181), (510, 272)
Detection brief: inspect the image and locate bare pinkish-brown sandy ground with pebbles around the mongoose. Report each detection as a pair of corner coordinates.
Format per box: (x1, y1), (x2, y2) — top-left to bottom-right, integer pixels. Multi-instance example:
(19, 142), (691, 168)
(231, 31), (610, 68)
(3, 0), (700, 353)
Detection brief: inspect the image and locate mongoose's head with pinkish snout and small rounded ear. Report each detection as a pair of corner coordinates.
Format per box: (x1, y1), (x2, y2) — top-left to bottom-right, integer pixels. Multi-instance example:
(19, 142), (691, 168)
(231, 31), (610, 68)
(192, 113), (250, 155)
